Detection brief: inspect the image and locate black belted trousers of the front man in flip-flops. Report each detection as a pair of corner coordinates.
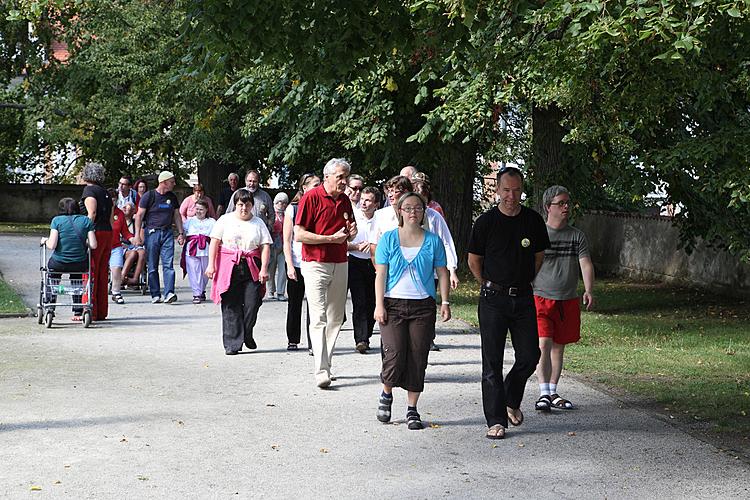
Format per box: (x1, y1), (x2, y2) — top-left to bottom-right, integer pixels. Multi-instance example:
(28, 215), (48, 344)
(479, 288), (541, 427)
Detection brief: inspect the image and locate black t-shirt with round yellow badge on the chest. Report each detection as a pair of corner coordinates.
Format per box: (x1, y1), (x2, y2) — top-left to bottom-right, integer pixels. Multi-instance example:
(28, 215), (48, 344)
(468, 206), (550, 288)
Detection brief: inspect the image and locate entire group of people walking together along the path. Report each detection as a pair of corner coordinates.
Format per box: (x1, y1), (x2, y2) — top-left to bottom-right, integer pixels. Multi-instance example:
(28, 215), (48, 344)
(42, 158), (594, 439)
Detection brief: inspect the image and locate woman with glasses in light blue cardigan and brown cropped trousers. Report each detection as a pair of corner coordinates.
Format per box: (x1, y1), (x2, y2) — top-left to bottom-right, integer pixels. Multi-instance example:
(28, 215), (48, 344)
(375, 193), (451, 430)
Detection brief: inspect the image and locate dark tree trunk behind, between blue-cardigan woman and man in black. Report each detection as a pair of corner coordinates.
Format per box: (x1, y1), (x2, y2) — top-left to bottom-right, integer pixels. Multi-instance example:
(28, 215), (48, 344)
(431, 142), (477, 269)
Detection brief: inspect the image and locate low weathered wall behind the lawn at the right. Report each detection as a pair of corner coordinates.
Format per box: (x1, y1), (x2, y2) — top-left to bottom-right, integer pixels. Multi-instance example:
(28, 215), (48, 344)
(575, 212), (750, 297)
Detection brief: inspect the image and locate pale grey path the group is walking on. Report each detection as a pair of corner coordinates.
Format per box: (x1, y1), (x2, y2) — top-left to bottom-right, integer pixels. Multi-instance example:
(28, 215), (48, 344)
(0, 236), (750, 498)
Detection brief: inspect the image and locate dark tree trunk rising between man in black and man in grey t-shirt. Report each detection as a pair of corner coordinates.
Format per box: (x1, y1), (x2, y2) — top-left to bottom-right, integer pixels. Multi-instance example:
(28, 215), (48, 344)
(526, 104), (566, 210)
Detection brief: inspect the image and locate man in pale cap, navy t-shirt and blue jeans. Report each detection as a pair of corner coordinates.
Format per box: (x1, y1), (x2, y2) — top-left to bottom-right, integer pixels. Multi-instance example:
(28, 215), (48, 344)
(135, 171), (185, 304)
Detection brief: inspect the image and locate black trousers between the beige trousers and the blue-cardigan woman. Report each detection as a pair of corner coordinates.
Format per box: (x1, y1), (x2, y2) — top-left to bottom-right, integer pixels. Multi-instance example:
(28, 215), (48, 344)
(349, 255), (375, 344)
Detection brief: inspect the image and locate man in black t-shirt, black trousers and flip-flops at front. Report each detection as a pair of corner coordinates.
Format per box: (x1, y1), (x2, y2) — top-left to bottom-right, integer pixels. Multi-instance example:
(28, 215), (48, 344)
(468, 167), (550, 439)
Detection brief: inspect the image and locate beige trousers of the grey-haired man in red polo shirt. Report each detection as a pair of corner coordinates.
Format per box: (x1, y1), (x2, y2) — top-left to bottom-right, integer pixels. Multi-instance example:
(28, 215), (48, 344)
(300, 262), (349, 377)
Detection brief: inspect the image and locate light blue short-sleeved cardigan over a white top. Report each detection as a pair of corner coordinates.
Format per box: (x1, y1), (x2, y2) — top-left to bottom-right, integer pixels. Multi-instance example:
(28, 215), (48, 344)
(375, 229), (446, 300)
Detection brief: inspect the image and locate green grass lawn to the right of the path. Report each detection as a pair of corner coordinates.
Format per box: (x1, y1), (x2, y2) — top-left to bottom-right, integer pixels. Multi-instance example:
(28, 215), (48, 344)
(452, 279), (750, 440)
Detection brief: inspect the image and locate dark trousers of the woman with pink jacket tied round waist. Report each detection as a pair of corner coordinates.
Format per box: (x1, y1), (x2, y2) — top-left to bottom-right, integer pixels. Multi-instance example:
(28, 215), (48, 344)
(221, 268), (263, 351)
